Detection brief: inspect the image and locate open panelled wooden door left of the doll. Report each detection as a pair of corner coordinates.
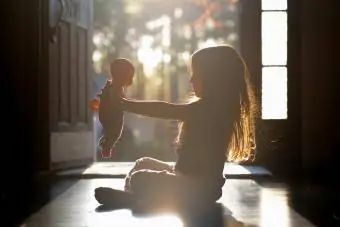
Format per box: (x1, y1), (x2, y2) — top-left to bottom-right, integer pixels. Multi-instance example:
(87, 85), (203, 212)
(48, 0), (94, 169)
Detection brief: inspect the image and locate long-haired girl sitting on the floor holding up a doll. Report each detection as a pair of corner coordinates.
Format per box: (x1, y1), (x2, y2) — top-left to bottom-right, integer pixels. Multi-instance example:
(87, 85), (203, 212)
(95, 45), (256, 211)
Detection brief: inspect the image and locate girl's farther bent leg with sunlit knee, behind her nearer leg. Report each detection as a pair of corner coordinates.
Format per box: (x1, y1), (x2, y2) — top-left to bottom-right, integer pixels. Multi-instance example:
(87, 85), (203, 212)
(124, 157), (173, 191)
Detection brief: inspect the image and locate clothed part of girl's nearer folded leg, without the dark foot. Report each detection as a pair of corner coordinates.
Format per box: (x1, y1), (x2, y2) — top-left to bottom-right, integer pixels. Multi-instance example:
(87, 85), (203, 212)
(127, 170), (222, 209)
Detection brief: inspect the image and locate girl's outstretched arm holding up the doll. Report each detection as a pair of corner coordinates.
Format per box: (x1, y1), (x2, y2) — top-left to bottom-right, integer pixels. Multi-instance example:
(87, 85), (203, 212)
(122, 98), (192, 120)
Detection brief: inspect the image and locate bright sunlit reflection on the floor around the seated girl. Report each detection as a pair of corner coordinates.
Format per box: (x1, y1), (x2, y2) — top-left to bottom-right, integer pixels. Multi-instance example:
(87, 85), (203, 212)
(22, 179), (313, 227)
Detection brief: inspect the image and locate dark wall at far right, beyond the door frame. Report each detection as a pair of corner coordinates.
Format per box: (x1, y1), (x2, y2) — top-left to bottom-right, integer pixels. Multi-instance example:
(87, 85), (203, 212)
(300, 0), (340, 176)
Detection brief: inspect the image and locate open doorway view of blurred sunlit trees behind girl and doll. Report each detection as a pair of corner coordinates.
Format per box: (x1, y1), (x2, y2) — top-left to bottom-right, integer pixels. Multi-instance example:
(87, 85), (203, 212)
(92, 0), (241, 162)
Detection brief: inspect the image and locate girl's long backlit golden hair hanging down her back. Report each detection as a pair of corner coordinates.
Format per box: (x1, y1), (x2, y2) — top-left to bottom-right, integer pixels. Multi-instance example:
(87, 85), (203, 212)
(176, 45), (257, 162)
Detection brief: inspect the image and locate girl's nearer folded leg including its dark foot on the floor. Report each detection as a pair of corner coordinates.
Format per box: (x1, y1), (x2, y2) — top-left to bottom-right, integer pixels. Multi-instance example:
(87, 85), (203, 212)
(96, 170), (224, 210)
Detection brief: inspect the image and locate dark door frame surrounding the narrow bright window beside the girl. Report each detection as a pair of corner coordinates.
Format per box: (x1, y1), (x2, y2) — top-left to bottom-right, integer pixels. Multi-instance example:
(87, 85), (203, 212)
(240, 0), (301, 176)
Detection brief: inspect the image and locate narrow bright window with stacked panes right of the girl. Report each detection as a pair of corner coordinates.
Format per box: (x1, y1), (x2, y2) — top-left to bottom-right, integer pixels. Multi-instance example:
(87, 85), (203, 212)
(261, 0), (288, 120)
